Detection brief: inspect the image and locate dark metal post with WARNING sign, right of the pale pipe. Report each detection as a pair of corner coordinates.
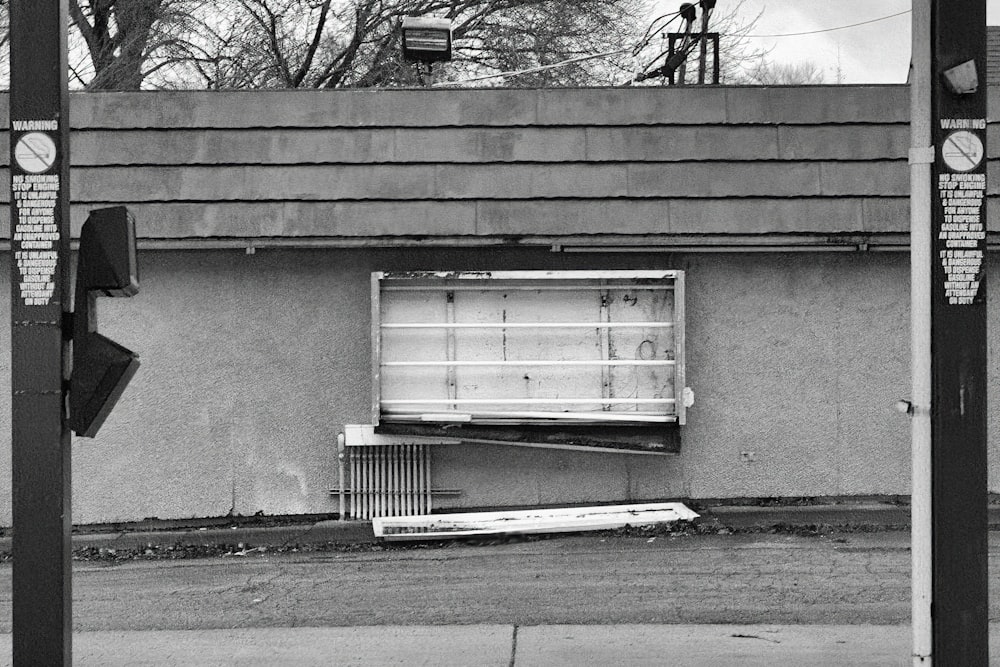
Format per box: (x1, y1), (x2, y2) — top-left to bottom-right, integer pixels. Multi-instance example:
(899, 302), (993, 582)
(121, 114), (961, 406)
(930, 0), (989, 667)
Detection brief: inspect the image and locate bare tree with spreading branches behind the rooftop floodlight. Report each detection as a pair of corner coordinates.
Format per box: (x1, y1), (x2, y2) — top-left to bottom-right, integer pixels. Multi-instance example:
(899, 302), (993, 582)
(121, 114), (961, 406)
(186, 0), (642, 88)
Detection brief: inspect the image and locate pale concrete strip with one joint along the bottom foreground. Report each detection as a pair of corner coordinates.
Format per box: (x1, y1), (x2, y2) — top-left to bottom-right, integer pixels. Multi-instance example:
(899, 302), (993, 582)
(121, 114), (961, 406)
(7, 625), (1000, 667)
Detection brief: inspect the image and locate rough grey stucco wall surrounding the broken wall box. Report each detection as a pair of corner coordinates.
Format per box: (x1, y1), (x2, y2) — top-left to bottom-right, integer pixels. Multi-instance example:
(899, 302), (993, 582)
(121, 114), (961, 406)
(0, 249), (1000, 524)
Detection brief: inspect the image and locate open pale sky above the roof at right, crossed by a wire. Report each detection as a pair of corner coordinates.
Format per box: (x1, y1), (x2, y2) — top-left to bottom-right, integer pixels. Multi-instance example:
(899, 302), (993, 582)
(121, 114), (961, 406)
(653, 0), (1000, 83)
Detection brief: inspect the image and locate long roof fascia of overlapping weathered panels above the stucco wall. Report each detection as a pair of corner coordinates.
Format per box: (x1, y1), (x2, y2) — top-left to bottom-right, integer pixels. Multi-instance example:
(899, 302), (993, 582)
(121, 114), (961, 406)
(0, 86), (984, 245)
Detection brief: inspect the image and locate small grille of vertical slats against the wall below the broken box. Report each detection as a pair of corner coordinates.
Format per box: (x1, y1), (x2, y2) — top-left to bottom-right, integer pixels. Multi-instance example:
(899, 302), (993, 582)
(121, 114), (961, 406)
(350, 444), (431, 520)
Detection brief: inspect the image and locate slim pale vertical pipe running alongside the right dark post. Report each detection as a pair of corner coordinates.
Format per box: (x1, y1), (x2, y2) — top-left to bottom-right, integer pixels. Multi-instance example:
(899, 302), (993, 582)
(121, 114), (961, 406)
(910, 0), (934, 667)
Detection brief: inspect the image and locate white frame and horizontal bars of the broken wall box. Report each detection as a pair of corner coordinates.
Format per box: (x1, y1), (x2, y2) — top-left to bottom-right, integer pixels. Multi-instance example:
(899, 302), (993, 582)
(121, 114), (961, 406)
(371, 270), (686, 426)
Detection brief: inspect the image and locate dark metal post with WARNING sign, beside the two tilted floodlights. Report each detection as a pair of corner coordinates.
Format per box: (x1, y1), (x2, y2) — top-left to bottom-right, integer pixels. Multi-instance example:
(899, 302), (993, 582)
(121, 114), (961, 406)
(10, 0), (72, 665)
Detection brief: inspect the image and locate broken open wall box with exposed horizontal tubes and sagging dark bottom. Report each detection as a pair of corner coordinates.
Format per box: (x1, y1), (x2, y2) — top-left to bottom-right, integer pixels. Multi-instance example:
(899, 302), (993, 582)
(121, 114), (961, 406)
(372, 271), (685, 451)
